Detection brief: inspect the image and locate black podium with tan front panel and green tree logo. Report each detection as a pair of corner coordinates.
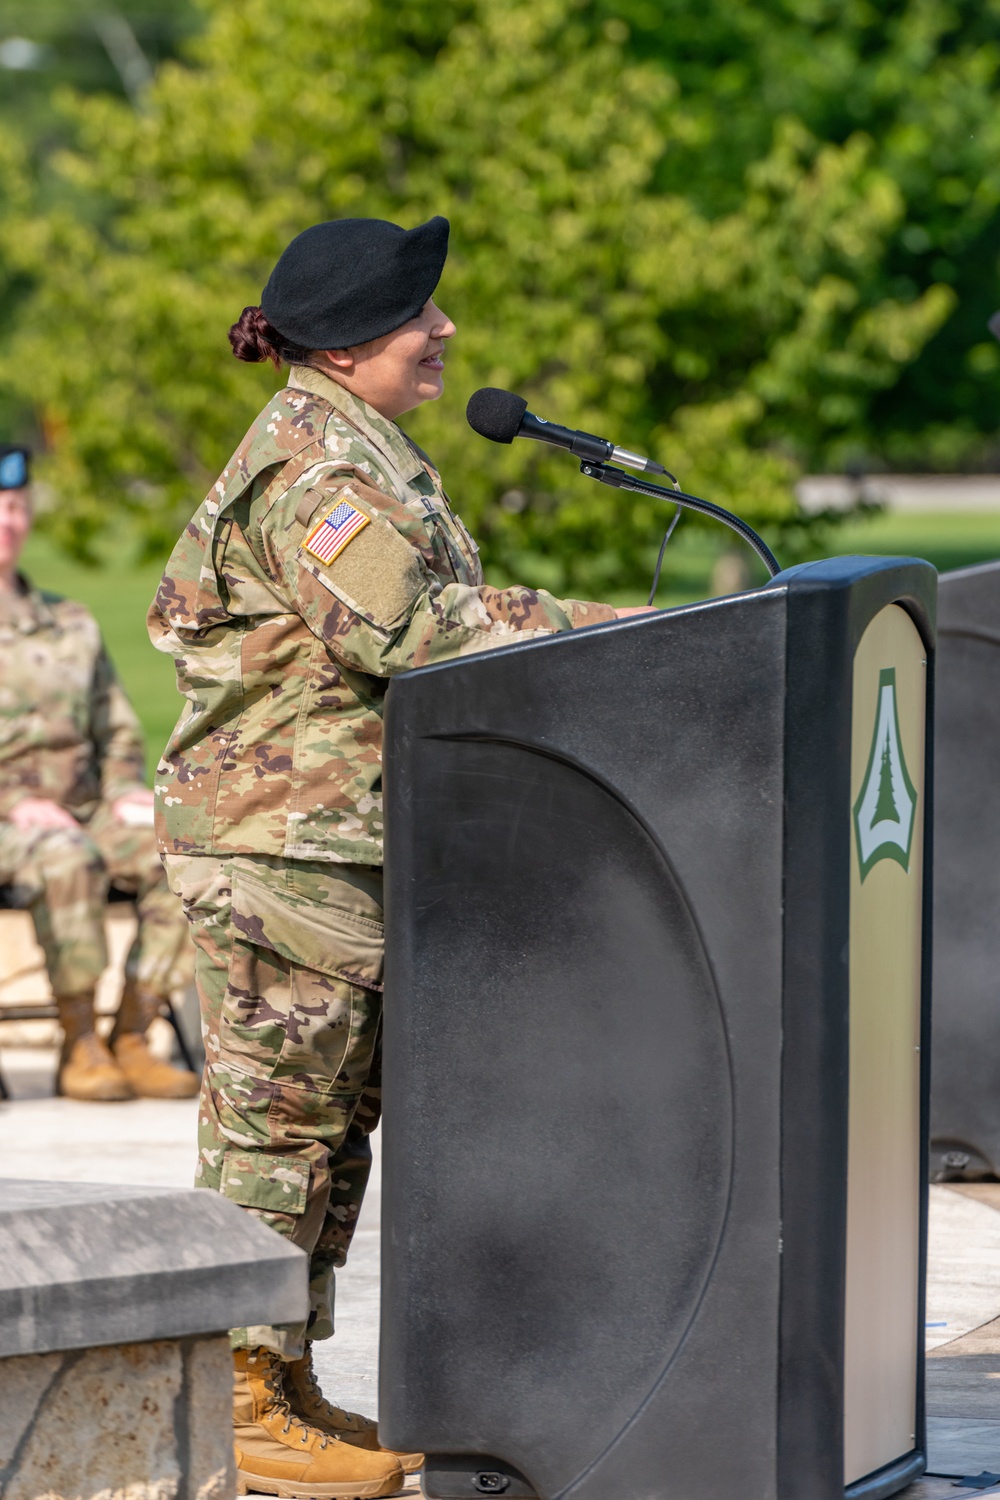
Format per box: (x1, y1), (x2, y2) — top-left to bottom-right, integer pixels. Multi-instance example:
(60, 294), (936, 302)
(379, 558), (936, 1500)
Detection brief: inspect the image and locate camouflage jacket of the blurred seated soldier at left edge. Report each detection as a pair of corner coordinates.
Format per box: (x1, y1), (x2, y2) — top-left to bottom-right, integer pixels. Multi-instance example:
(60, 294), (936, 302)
(0, 576), (144, 822)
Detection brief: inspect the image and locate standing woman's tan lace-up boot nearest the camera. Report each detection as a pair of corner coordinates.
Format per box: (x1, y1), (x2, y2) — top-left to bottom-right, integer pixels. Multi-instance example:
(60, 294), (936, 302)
(232, 1349), (405, 1500)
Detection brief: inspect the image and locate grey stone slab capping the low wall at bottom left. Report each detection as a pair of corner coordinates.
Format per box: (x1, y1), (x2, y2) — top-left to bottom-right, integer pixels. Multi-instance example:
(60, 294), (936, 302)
(0, 1179), (307, 1358)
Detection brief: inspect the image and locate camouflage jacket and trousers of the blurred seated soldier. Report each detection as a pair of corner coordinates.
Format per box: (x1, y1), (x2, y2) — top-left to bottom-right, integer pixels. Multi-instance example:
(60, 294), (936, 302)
(0, 576), (192, 996)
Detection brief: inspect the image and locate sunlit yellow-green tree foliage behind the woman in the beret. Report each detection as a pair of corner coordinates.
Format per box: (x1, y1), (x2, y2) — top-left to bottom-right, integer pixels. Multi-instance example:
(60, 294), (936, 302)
(0, 0), (990, 594)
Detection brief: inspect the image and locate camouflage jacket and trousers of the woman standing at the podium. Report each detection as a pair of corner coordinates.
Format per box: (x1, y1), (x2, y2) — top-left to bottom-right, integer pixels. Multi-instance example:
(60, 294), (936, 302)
(148, 368), (613, 1359)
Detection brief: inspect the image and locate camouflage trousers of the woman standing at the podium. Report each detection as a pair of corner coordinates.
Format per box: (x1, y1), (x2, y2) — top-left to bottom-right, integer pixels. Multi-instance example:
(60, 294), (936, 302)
(163, 854), (382, 1359)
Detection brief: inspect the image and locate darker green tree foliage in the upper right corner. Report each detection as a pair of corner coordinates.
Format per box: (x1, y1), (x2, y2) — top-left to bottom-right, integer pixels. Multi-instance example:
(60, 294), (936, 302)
(601, 0), (1000, 470)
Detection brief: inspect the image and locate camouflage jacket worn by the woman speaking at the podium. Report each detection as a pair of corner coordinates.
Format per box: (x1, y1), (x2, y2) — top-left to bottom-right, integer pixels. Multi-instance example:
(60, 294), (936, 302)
(148, 366), (613, 864)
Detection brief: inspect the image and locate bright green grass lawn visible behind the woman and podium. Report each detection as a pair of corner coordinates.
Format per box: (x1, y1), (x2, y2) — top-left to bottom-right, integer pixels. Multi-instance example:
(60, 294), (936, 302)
(24, 512), (1000, 771)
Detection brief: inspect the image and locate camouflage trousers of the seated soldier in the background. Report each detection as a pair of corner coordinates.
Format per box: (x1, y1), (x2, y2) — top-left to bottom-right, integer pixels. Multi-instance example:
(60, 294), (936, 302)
(0, 804), (192, 995)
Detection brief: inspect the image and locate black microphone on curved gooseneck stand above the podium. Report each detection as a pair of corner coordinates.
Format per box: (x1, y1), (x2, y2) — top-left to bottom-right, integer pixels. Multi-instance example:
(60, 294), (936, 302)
(465, 386), (781, 579)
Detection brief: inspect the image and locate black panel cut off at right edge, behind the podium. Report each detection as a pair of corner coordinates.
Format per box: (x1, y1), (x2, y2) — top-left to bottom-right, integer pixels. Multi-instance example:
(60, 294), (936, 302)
(931, 563), (1000, 1178)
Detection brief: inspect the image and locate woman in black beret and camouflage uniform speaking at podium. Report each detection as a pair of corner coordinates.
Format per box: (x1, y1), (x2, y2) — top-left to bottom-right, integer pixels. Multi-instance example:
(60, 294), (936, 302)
(150, 218), (641, 1497)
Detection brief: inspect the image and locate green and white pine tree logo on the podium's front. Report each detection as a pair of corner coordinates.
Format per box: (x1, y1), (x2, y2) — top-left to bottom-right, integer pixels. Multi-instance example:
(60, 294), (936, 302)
(855, 666), (916, 881)
